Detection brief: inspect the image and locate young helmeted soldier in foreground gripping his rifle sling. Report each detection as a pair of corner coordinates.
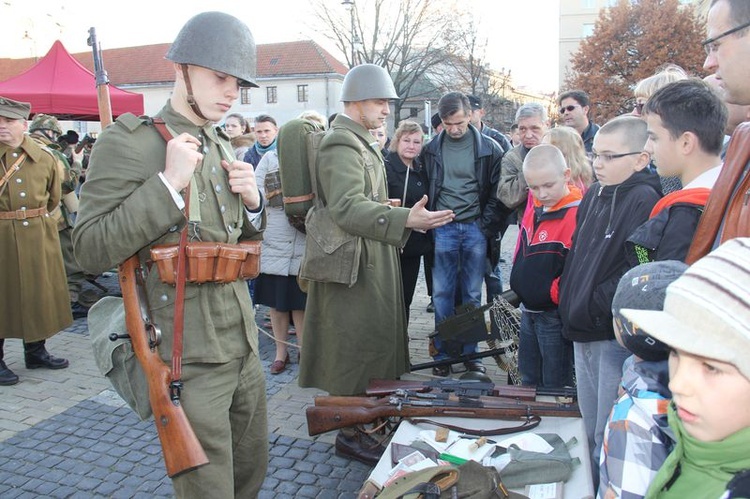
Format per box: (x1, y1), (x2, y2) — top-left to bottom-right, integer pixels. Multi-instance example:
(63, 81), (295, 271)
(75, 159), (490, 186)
(73, 12), (268, 498)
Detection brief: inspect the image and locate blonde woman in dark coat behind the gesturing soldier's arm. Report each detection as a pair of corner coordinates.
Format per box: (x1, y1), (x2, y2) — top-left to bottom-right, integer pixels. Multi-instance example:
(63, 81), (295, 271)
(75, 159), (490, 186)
(385, 120), (432, 320)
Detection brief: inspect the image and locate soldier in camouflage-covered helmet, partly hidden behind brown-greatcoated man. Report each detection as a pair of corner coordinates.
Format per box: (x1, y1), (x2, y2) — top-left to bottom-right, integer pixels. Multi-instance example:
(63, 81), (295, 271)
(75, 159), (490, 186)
(29, 114), (88, 319)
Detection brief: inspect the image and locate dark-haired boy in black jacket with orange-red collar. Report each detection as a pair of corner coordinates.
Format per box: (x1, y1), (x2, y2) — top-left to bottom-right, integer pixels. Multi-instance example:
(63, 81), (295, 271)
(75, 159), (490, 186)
(626, 78), (727, 265)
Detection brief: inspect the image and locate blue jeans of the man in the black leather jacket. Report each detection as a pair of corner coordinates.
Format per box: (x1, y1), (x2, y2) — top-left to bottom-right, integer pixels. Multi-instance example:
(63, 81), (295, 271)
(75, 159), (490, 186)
(432, 219), (487, 360)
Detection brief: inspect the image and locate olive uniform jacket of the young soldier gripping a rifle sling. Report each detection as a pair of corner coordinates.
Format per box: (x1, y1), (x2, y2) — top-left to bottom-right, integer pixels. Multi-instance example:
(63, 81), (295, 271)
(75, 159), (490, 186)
(73, 103), (266, 366)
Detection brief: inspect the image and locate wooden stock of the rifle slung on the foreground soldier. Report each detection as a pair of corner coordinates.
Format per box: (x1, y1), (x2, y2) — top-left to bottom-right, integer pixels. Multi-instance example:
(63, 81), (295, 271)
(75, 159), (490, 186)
(119, 255), (208, 478)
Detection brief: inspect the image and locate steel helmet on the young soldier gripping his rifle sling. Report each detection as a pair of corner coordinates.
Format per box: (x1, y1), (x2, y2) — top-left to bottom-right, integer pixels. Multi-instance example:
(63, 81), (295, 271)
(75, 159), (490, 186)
(166, 12), (258, 87)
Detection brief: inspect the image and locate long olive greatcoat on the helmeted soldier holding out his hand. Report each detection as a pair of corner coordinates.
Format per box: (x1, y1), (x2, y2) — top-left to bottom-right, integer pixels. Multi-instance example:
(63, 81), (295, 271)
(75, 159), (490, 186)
(299, 114), (411, 395)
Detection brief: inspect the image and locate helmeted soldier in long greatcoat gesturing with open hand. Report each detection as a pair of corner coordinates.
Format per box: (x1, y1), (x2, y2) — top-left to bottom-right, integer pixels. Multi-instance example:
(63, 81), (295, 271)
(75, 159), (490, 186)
(299, 64), (453, 462)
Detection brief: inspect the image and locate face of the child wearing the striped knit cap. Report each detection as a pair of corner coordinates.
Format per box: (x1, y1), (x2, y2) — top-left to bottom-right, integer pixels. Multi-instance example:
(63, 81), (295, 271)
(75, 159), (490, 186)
(669, 350), (750, 442)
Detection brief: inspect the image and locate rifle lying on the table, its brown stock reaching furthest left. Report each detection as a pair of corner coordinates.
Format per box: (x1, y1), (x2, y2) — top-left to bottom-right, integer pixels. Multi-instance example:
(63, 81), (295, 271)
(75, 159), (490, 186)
(306, 392), (580, 436)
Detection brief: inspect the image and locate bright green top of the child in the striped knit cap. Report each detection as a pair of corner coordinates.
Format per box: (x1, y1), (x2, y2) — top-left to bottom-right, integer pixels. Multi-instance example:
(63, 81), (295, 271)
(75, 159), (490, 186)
(646, 404), (750, 499)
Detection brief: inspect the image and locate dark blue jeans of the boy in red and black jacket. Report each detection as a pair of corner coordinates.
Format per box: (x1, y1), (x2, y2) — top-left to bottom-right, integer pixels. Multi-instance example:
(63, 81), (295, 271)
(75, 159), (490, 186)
(518, 309), (573, 387)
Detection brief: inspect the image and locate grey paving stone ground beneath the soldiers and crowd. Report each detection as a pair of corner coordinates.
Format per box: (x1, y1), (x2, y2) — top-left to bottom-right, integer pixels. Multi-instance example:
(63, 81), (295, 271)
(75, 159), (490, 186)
(0, 227), (517, 499)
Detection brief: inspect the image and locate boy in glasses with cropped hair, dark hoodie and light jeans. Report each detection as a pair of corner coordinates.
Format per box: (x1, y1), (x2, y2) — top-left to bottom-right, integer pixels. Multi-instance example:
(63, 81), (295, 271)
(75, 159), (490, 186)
(559, 116), (661, 490)
